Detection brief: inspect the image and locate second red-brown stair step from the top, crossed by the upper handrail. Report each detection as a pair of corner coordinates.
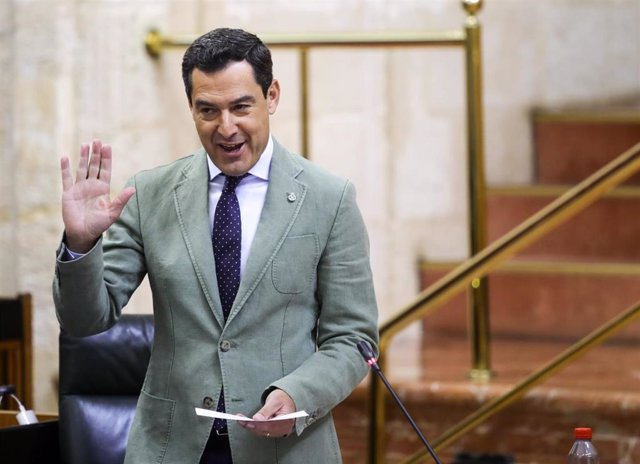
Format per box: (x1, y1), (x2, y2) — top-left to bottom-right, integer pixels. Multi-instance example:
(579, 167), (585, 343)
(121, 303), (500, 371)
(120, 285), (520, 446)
(487, 187), (640, 262)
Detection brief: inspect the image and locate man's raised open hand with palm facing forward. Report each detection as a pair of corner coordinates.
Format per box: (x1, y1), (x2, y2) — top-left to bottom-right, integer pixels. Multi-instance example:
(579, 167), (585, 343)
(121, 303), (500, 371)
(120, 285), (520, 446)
(60, 140), (135, 253)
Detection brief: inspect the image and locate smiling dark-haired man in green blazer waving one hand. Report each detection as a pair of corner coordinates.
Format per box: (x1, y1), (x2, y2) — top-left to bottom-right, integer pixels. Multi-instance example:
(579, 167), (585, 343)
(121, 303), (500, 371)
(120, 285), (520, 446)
(53, 29), (377, 464)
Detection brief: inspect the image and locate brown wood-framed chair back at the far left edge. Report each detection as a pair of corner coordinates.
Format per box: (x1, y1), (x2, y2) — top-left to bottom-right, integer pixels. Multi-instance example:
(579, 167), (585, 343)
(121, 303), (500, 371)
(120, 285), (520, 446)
(0, 293), (33, 408)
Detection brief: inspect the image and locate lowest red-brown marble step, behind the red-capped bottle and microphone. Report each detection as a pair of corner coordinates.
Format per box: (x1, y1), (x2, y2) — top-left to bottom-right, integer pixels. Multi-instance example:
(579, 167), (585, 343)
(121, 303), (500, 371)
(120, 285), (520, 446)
(334, 335), (640, 464)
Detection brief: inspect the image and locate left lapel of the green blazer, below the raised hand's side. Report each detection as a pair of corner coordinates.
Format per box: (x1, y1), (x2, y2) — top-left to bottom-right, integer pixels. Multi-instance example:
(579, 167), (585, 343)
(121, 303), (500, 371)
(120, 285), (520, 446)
(173, 150), (224, 327)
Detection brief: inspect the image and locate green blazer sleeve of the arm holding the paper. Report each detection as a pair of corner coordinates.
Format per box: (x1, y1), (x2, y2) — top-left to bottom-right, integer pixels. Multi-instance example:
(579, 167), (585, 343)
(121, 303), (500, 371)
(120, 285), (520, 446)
(263, 182), (378, 434)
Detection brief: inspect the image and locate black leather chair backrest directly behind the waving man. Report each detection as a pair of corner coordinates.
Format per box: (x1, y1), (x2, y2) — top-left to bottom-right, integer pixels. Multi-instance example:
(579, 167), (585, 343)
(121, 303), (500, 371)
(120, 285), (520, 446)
(59, 315), (154, 464)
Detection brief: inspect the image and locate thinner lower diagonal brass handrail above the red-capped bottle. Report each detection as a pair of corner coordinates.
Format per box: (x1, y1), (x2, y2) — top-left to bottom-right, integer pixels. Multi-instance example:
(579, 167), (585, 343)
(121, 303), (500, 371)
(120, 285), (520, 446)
(403, 301), (640, 464)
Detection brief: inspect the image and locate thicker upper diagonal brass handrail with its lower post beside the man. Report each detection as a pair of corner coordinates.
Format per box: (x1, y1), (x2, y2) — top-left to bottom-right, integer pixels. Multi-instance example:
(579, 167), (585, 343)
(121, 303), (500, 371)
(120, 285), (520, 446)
(369, 143), (640, 463)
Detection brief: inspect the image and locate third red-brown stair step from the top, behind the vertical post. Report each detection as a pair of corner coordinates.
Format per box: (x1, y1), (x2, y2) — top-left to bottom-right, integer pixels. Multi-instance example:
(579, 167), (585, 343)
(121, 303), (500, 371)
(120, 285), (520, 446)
(420, 261), (640, 340)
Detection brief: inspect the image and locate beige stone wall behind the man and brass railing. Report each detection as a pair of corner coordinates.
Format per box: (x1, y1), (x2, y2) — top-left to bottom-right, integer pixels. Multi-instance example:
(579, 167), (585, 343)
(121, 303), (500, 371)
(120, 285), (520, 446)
(0, 0), (640, 410)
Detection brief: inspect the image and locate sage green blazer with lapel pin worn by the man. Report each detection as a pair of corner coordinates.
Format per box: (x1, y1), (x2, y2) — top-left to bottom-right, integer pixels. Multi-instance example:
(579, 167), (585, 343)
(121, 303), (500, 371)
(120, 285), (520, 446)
(53, 142), (378, 464)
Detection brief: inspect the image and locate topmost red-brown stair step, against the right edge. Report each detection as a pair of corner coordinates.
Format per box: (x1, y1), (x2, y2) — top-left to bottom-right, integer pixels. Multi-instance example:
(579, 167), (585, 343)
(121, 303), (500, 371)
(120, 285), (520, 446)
(533, 106), (640, 185)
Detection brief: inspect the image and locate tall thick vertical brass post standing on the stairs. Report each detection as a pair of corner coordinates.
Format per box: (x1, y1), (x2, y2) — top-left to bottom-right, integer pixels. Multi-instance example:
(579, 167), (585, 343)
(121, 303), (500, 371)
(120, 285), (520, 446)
(462, 0), (491, 381)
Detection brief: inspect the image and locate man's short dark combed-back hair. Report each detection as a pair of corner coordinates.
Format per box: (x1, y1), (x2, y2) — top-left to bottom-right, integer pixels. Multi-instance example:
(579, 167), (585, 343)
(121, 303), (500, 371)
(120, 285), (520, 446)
(182, 28), (273, 103)
